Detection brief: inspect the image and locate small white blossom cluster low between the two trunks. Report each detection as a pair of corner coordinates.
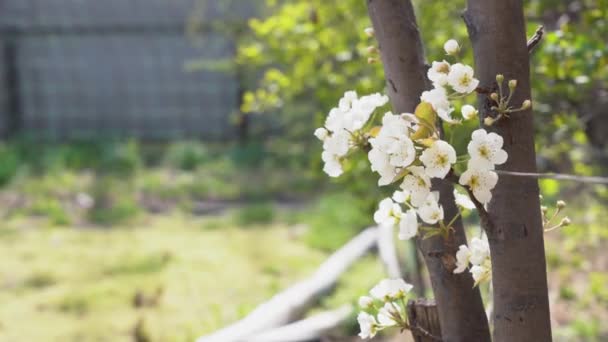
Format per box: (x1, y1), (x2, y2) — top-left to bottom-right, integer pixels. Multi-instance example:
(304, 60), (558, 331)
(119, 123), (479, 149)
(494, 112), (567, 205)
(454, 235), (492, 285)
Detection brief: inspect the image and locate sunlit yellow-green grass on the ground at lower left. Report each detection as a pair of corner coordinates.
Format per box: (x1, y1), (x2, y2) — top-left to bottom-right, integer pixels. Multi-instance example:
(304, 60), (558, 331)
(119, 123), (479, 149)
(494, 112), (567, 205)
(0, 214), (382, 341)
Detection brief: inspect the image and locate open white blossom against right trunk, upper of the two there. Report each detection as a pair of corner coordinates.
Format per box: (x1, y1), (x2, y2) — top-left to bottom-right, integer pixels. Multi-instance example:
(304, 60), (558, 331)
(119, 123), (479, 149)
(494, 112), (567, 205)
(467, 129), (508, 169)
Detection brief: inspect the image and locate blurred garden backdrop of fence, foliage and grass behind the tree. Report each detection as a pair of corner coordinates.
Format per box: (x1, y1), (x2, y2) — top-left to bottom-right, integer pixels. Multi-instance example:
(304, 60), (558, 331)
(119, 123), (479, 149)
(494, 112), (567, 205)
(0, 0), (608, 342)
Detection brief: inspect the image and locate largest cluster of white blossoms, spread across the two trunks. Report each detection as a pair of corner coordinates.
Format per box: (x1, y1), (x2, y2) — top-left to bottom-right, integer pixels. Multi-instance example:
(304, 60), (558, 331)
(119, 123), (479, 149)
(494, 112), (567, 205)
(315, 40), (507, 240)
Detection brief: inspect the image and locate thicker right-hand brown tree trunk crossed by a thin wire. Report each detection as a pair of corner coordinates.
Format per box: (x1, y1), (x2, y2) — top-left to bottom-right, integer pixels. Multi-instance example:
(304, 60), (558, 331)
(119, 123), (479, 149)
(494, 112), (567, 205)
(464, 0), (551, 342)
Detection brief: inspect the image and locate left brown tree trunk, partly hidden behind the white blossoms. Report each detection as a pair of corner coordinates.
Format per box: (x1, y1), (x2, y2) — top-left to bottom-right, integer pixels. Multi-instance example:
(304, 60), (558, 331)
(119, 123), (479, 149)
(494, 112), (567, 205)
(367, 0), (490, 342)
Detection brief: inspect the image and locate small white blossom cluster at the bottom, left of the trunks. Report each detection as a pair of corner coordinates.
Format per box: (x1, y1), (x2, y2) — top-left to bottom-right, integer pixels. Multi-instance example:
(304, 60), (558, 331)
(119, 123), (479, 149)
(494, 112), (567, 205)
(357, 279), (413, 338)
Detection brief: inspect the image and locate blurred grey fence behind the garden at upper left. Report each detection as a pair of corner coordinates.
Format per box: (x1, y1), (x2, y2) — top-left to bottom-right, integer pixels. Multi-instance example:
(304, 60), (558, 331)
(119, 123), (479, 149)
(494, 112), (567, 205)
(0, 0), (254, 140)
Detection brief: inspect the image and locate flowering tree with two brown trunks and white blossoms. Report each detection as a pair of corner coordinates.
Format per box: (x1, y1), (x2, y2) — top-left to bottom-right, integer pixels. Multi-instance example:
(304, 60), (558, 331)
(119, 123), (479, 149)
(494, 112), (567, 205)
(315, 0), (567, 341)
